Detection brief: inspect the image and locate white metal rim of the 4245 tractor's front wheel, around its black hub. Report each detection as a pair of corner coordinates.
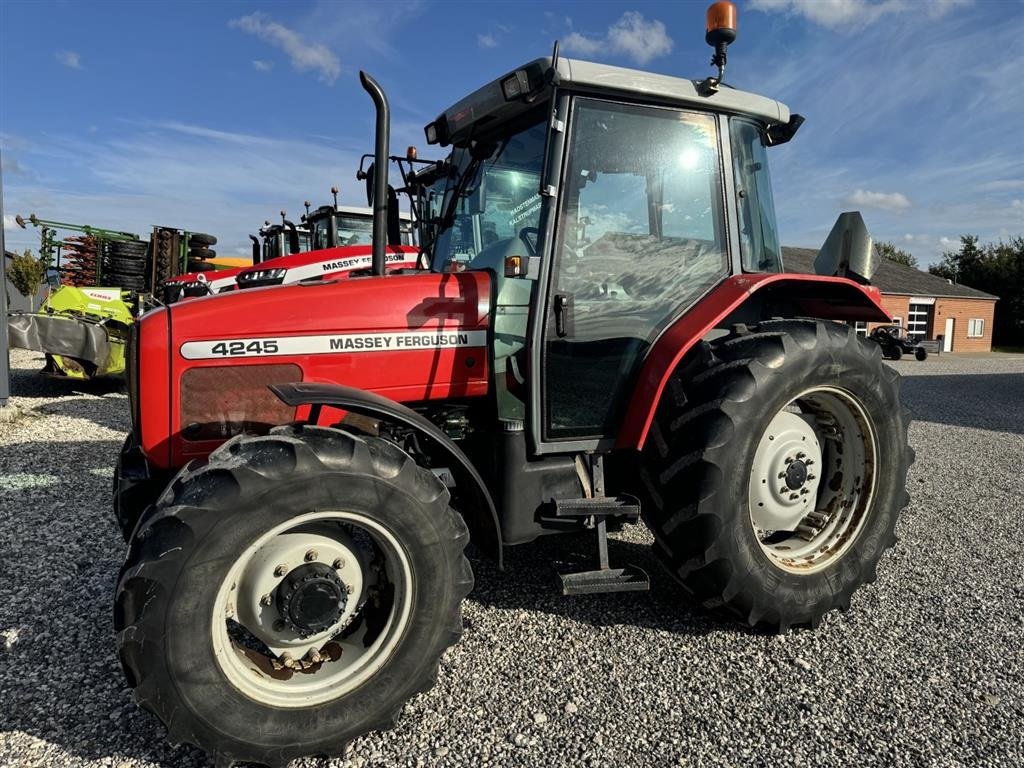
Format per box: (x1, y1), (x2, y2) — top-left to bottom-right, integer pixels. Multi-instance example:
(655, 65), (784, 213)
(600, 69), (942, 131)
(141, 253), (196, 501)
(211, 511), (413, 708)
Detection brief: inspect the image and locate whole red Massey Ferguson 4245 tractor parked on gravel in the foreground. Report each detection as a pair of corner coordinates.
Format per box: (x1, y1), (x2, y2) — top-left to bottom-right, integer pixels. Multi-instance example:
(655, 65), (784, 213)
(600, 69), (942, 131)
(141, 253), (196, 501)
(115, 4), (912, 766)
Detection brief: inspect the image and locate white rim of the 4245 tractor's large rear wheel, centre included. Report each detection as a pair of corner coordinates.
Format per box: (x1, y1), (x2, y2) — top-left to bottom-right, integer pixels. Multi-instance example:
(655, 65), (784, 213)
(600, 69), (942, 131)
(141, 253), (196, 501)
(748, 387), (878, 574)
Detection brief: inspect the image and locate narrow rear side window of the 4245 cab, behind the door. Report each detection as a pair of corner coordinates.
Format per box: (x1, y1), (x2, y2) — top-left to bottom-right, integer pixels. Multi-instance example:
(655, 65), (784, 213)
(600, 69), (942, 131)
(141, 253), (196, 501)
(729, 118), (782, 272)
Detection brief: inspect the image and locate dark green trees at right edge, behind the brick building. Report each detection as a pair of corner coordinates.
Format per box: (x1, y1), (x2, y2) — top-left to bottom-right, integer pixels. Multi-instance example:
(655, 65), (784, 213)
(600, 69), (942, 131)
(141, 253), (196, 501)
(928, 234), (1024, 346)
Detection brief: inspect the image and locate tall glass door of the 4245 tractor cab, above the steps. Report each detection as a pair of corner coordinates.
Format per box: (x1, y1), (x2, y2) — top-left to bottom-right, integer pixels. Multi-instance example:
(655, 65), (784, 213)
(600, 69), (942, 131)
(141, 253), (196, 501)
(531, 96), (729, 453)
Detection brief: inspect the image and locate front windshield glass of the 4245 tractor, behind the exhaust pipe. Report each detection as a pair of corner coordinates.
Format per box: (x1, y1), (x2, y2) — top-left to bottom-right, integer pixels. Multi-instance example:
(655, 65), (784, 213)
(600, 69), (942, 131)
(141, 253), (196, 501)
(429, 117), (546, 274)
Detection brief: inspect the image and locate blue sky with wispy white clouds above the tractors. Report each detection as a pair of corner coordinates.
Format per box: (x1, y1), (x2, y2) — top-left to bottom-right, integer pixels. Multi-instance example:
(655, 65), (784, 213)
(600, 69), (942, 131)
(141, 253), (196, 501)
(0, 0), (1024, 264)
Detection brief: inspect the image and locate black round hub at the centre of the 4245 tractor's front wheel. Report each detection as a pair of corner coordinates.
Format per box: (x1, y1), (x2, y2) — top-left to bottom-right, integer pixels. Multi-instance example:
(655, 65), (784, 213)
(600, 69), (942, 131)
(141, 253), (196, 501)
(275, 562), (348, 637)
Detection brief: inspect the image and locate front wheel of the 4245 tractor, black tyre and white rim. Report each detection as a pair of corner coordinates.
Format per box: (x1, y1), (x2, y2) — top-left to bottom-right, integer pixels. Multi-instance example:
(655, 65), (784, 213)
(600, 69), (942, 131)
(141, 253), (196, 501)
(115, 426), (473, 766)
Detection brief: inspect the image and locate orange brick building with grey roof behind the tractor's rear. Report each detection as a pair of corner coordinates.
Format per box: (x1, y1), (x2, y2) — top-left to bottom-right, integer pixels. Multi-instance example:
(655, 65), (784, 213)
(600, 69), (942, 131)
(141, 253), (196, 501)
(782, 248), (998, 352)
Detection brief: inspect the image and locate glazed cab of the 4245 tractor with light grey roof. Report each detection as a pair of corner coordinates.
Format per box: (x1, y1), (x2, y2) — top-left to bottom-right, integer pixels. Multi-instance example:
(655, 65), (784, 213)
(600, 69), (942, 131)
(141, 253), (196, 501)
(415, 52), (802, 438)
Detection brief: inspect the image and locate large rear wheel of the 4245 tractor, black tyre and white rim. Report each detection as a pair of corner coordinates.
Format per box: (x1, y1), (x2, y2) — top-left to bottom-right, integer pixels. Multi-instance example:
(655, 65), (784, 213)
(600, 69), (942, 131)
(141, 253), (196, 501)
(640, 321), (913, 631)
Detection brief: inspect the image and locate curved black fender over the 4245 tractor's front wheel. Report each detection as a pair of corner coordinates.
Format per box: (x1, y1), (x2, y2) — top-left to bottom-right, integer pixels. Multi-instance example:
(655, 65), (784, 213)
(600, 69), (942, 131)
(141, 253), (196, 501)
(270, 382), (504, 568)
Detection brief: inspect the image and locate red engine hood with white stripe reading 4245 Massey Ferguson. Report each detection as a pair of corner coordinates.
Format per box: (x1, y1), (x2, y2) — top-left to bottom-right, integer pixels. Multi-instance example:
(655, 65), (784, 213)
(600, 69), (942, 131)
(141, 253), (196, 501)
(133, 271), (490, 466)
